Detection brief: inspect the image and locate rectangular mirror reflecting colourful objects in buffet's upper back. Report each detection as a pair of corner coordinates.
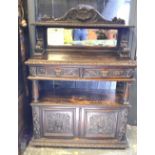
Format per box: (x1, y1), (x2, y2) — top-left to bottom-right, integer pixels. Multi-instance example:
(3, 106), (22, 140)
(47, 28), (118, 47)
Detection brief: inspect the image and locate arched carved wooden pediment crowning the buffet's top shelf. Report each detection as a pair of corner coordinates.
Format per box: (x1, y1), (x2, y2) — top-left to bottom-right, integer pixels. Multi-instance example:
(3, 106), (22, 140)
(41, 5), (125, 24)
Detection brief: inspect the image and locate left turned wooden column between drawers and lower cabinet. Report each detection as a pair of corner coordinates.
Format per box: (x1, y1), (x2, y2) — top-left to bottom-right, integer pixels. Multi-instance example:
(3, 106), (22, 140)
(32, 80), (39, 102)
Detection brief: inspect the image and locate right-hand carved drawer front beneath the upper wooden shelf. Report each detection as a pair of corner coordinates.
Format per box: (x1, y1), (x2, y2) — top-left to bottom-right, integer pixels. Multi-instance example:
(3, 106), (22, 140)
(83, 69), (134, 78)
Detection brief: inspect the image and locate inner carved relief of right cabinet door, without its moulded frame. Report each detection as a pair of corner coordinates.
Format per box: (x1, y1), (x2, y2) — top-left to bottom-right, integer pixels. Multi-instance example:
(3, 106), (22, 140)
(86, 112), (117, 137)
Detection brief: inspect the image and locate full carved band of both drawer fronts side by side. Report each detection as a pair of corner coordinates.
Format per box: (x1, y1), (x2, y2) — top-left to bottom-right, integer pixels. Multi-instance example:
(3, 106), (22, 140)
(29, 66), (134, 78)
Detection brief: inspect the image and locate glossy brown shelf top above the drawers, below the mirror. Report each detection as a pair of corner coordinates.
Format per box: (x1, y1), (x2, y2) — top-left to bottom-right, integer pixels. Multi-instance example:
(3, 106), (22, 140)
(25, 51), (136, 68)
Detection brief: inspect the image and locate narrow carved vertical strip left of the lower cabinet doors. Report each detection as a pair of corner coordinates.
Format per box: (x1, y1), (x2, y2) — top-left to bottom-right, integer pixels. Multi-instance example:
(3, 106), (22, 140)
(32, 107), (41, 138)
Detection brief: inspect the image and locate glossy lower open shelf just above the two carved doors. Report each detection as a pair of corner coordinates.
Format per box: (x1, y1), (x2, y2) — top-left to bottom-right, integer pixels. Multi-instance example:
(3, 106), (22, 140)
(32, 89), (129, 107)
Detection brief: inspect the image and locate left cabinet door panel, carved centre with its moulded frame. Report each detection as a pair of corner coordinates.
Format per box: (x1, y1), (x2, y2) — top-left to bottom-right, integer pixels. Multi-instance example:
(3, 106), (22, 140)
(42, 107), (78, 138)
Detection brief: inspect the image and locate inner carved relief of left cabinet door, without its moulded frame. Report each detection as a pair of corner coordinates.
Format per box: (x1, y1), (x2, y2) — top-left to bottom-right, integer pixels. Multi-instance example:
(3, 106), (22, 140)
(45, 112), (72, 133)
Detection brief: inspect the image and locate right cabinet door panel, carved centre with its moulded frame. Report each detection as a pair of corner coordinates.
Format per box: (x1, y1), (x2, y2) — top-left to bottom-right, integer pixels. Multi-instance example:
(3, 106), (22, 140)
(81, 108), (119, 139)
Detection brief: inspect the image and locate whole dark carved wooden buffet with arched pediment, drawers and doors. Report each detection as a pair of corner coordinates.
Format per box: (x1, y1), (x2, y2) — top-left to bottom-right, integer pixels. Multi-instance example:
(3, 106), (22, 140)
(25, 5), (136, 148)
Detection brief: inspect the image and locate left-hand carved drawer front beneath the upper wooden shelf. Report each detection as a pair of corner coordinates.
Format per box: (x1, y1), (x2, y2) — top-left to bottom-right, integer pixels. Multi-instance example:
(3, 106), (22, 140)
(30, 66), (79, 78)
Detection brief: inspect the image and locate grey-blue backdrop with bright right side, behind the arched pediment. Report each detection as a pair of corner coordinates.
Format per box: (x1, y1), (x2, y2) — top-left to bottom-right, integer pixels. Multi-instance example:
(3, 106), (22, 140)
(36, 0), (133, 24)
